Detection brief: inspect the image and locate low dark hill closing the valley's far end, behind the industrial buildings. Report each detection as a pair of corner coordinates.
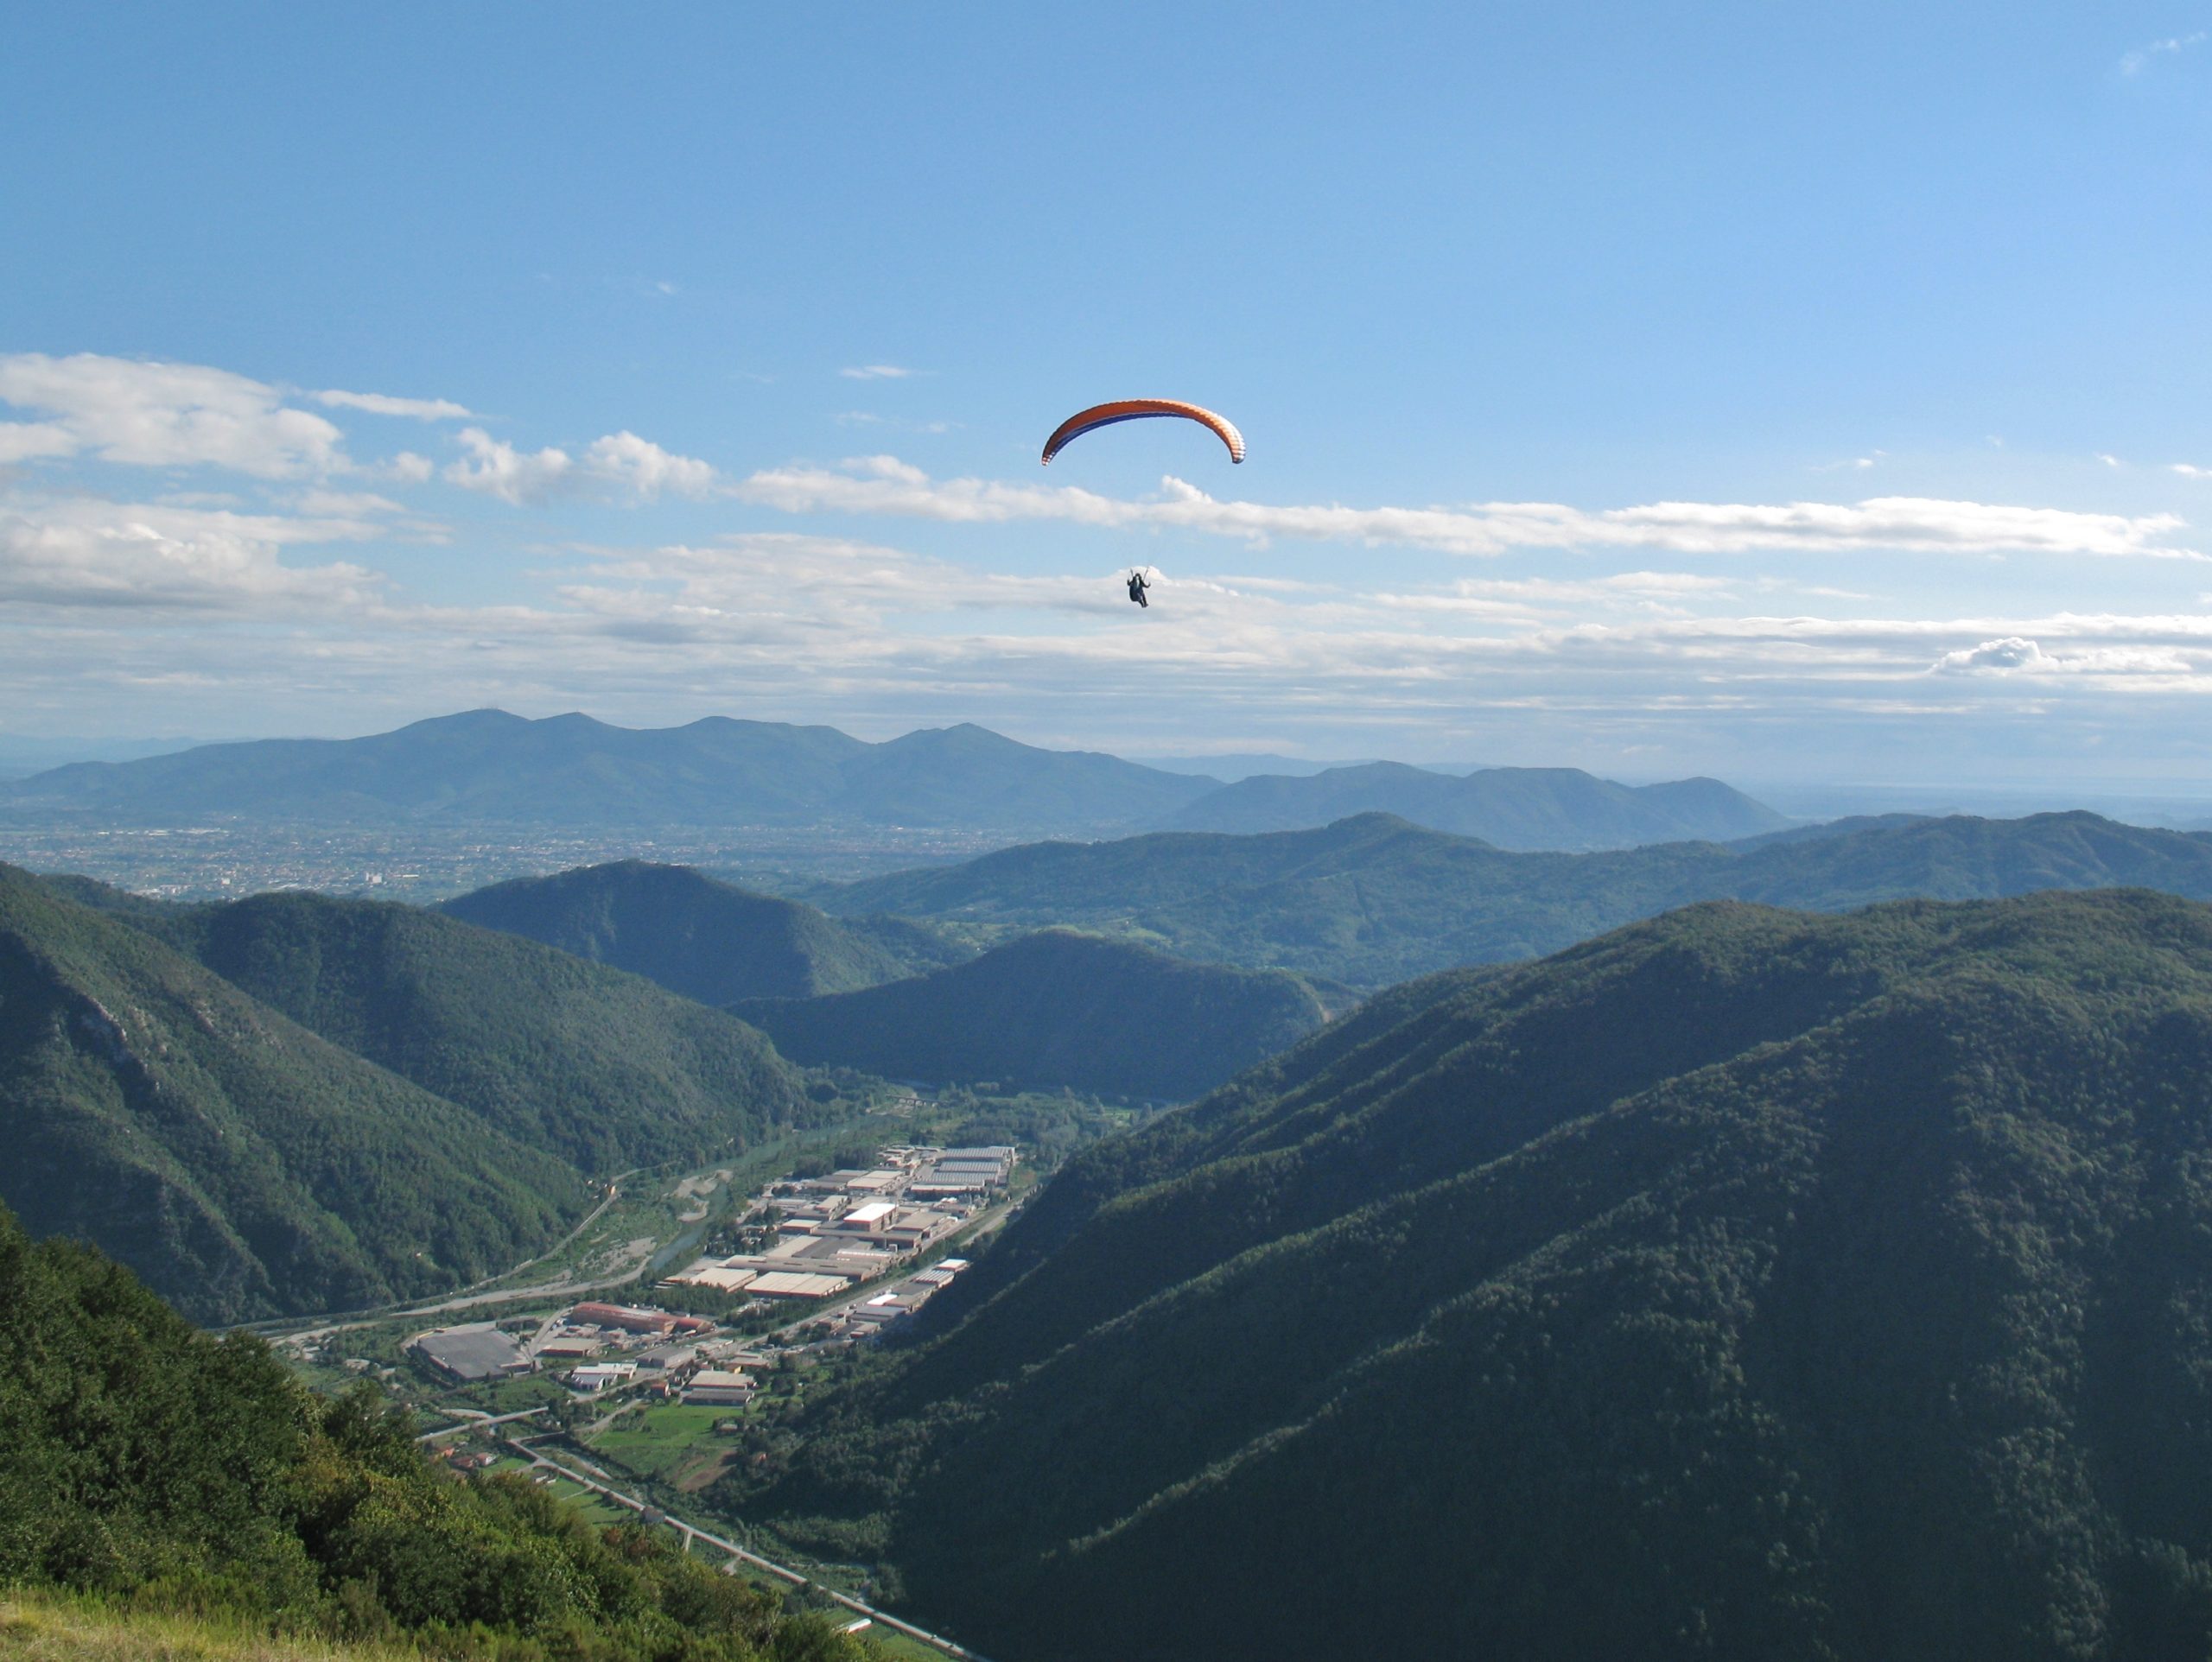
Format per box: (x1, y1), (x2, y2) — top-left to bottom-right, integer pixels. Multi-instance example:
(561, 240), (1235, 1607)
(736, 930), (1327, 1099)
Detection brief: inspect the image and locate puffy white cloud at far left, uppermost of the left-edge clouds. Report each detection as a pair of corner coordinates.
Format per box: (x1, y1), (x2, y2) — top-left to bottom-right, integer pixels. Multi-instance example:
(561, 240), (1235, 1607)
(0, 352), (345, 479)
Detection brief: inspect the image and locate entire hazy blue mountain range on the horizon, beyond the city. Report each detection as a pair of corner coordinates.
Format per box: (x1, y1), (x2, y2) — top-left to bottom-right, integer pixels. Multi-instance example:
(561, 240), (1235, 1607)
(0, 709), (1787, 848)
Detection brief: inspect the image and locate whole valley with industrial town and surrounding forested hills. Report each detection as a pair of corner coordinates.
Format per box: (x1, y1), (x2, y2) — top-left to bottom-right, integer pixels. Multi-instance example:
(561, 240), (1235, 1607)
(13, 733), (2212, 1662)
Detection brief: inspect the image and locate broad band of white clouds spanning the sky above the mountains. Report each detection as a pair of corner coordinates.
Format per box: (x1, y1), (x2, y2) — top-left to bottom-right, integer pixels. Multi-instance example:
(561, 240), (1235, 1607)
(13, 353), (2212, 771)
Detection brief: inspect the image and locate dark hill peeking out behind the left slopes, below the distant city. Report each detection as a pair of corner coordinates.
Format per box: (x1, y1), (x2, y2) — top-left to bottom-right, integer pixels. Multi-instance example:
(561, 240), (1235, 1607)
(440, 860), (957, 1004)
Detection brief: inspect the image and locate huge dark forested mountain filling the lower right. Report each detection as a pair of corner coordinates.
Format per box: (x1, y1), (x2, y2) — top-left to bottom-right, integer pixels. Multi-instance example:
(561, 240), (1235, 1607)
(723, 893), (2212, 1662)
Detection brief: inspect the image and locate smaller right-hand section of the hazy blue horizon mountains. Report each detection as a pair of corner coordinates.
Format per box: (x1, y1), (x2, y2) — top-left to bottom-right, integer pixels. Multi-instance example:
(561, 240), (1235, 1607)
(1173, 763), (1789, 848)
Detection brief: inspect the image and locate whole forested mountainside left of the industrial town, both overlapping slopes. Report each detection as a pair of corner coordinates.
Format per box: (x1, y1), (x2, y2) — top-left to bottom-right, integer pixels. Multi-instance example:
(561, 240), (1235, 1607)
(0, 866), (823, 1322)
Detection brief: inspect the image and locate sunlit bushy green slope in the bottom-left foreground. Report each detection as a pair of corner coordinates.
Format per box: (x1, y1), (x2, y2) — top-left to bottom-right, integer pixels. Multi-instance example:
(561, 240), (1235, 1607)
(0, 1209), (865, 1662)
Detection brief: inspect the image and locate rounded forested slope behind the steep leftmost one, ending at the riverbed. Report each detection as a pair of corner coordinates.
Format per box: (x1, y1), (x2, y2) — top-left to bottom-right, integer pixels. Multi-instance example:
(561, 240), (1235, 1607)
(162, 895), (810, 1176)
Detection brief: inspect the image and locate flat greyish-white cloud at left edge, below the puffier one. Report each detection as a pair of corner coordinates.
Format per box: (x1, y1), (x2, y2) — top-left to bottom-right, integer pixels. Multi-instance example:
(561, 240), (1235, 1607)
(0, 498), (380, 612)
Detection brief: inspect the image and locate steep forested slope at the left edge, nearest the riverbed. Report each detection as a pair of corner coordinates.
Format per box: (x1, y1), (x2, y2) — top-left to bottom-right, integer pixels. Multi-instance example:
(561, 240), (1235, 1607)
(0, 866), (586, 1322)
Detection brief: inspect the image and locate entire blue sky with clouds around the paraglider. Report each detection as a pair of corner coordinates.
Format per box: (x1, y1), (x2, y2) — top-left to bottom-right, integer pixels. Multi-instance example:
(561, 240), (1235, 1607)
(0, 4), (2212, 794)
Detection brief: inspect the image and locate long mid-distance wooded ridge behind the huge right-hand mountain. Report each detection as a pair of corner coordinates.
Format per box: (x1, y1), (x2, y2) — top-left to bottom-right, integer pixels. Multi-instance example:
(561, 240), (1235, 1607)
(814, 814), (2212, 988)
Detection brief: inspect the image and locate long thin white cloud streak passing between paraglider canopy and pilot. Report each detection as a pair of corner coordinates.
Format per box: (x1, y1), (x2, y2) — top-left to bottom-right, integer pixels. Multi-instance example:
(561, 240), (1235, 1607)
(730, 455), (2201, 559)
